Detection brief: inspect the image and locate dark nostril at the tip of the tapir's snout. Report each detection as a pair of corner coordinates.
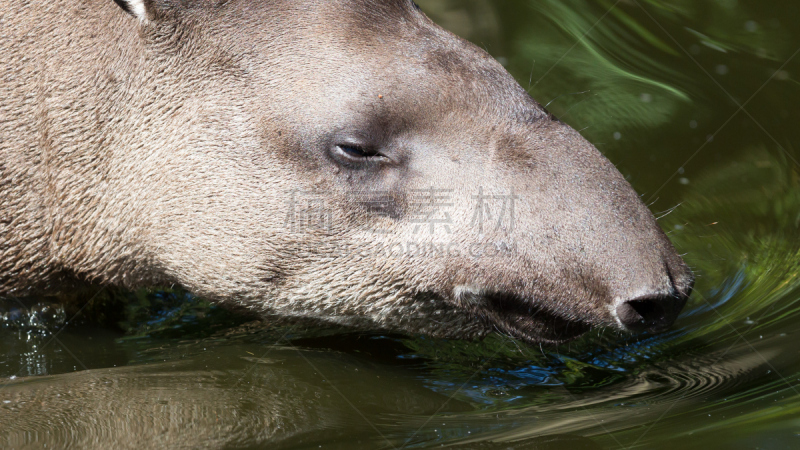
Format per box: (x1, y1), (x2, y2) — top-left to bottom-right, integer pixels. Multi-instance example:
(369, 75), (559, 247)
(617, 295), (686, 332)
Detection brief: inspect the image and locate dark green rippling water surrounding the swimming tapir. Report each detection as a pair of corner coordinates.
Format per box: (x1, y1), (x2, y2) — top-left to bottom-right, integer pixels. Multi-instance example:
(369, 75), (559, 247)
(0, 0), (800, 450)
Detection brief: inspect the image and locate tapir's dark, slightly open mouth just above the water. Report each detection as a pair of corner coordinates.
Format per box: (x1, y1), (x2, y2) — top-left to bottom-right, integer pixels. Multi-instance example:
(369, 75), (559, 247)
(479, 294), (591, 344)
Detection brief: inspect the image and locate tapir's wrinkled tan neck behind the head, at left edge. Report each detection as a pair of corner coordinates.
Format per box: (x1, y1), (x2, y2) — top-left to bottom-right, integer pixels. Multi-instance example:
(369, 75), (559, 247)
(0, 0), (155, 295)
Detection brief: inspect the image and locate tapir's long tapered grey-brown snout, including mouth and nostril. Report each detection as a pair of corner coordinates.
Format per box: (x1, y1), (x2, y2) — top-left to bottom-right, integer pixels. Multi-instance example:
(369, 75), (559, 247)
(432, 117), (694, 342)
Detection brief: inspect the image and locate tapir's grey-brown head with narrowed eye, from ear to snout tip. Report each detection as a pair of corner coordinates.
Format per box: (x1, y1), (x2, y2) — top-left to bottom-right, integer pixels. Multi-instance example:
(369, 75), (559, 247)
(108, 0), (693, 342)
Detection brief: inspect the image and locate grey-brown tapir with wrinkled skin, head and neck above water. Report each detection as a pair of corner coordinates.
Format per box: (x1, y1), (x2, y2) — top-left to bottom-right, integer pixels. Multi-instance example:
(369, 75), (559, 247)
(0, 0), (693, 342)
